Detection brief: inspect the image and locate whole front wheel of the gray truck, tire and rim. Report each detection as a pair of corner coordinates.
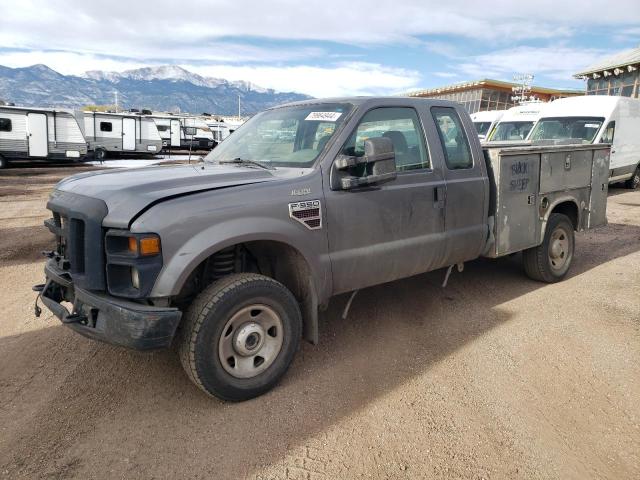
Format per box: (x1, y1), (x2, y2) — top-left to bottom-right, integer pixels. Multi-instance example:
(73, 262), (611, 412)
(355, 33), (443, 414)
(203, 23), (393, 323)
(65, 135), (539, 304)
(178, 273), (302, 401)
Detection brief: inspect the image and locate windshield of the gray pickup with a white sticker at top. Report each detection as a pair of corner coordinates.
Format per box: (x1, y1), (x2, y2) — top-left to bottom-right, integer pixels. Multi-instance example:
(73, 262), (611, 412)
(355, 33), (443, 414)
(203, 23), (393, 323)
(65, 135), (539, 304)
(205, 103), (351, 167)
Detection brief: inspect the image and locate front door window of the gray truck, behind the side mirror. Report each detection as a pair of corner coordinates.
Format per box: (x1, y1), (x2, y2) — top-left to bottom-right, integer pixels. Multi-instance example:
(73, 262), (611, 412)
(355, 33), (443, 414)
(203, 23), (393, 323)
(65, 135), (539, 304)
(342, 107), (431, 172)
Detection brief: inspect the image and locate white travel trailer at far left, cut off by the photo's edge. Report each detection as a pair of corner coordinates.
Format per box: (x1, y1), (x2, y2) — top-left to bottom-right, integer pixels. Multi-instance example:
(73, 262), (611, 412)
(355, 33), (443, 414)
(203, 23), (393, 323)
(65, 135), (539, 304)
(0, 106), (87, 168)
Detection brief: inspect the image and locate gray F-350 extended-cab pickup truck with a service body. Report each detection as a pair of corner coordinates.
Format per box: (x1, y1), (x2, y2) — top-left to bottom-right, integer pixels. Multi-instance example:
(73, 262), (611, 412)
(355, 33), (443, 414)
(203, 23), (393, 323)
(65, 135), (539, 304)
(34, 97), (609, 400)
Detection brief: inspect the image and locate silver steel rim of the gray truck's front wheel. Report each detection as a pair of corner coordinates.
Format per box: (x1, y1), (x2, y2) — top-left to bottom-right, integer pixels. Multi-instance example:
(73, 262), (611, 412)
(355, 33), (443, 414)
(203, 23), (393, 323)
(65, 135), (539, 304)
(218, 304), (284, 378)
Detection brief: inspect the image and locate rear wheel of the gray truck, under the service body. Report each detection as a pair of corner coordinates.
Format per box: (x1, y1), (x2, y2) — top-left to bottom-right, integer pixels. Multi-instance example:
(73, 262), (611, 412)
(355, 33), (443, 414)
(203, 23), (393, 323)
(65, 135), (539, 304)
(522, 213), (575, 283)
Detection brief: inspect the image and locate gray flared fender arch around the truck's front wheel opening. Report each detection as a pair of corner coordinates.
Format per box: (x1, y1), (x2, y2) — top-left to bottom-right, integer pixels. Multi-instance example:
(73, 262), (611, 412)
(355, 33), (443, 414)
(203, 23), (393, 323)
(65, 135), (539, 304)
(151, 216), (331, 299)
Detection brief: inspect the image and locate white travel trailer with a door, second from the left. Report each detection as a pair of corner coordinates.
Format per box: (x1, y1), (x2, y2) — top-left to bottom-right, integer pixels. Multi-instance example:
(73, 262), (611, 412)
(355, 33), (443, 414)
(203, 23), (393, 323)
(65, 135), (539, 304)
(84, 112), (162, 160)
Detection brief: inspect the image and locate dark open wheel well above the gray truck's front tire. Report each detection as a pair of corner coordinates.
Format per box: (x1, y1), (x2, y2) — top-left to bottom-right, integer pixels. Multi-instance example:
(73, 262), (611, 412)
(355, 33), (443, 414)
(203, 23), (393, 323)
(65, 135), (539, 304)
(172, 240), (318, 343)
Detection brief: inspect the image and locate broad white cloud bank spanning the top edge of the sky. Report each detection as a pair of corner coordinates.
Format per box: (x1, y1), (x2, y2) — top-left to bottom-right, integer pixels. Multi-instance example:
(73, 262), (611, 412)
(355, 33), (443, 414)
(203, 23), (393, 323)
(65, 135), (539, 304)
(0, 0), (640, 60)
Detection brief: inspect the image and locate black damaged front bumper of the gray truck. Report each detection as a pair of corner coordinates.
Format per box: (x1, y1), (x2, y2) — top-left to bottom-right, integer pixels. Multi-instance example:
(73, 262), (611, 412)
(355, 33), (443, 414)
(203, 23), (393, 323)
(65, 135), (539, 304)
(41, 260), (182, 350)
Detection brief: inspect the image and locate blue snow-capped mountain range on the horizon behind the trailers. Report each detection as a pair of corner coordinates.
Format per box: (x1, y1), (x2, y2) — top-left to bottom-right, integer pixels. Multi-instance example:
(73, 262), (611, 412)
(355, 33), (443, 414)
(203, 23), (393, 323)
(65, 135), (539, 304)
(0, 64), (311, 115)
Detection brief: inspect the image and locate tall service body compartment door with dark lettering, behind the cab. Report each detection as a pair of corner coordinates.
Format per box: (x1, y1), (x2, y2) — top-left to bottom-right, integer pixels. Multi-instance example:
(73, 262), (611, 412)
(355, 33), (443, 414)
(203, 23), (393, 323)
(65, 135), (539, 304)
(494, 154), (540, 255)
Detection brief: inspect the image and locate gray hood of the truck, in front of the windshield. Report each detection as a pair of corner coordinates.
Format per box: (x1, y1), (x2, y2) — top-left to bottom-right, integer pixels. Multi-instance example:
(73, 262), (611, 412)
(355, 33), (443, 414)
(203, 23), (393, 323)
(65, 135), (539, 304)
(56, 163), (280, 228)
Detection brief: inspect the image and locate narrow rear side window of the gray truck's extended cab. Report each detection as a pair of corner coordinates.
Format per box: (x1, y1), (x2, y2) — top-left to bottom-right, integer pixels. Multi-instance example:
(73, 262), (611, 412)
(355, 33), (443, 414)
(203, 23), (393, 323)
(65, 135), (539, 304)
(431, 107), (473, 170)
